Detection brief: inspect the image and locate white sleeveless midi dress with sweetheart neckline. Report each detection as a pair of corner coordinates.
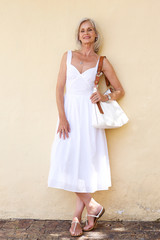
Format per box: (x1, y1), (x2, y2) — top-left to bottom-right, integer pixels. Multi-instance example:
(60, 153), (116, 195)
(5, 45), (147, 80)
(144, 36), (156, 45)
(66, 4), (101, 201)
(48, 51), (111, 193)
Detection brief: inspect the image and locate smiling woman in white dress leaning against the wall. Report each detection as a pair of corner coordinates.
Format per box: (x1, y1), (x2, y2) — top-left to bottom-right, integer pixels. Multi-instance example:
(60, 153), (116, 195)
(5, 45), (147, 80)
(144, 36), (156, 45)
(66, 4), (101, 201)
(48, 18), (124, 236)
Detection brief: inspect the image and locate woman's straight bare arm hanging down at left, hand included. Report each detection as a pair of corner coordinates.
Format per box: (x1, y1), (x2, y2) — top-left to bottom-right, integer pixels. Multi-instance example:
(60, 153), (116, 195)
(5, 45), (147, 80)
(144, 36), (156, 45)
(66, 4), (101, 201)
(56, 53), (70, 139)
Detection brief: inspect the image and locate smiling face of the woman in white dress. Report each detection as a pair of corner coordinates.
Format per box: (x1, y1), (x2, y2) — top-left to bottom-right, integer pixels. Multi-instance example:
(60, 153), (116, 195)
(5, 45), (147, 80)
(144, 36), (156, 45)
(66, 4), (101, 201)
(79, 21), (97, 44)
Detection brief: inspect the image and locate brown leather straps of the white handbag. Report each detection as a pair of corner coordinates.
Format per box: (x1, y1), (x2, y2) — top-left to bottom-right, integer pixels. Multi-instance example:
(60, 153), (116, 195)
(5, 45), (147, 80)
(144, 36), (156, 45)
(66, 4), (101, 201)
(94, 56), (110, 114)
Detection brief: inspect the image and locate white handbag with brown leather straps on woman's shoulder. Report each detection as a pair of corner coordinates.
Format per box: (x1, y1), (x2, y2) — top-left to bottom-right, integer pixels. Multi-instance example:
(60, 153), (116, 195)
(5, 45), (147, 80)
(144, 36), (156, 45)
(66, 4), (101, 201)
(92, 57), (129, 129)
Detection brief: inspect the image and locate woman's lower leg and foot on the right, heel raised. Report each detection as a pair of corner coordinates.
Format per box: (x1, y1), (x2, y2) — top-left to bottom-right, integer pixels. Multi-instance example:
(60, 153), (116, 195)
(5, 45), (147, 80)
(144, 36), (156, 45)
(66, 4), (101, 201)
(76, 193), (102, 230)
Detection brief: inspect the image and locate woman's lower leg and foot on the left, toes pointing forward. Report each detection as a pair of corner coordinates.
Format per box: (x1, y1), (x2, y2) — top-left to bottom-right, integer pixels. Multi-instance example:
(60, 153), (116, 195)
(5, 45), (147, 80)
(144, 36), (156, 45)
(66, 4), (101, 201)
(70, 196), (85, 236)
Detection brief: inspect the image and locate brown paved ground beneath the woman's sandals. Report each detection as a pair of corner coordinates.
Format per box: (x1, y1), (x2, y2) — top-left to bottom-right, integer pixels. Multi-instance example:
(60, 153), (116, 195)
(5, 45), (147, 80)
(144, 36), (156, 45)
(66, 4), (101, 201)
(0, 219), (160, 240)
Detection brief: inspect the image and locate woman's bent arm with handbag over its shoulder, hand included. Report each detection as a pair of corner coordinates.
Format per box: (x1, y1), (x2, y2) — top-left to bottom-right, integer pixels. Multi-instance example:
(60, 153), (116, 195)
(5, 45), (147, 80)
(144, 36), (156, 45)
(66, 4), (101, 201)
(91, 58), (125, 103)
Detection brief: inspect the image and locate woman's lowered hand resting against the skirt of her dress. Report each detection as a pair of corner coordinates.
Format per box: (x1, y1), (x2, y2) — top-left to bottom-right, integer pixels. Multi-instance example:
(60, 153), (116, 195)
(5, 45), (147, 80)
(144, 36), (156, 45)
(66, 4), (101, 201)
(57, 118), (71, 139)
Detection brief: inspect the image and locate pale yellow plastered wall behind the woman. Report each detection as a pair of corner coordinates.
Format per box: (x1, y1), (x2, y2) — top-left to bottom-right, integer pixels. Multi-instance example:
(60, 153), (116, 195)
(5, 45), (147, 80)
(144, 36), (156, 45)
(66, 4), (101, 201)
(0, 0), (160, 220)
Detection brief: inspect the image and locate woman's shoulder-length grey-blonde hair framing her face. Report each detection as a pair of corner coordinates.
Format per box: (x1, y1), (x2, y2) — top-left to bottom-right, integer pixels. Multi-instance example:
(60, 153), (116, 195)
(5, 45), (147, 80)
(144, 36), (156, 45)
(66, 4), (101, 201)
(76, 18), (100, 53)
